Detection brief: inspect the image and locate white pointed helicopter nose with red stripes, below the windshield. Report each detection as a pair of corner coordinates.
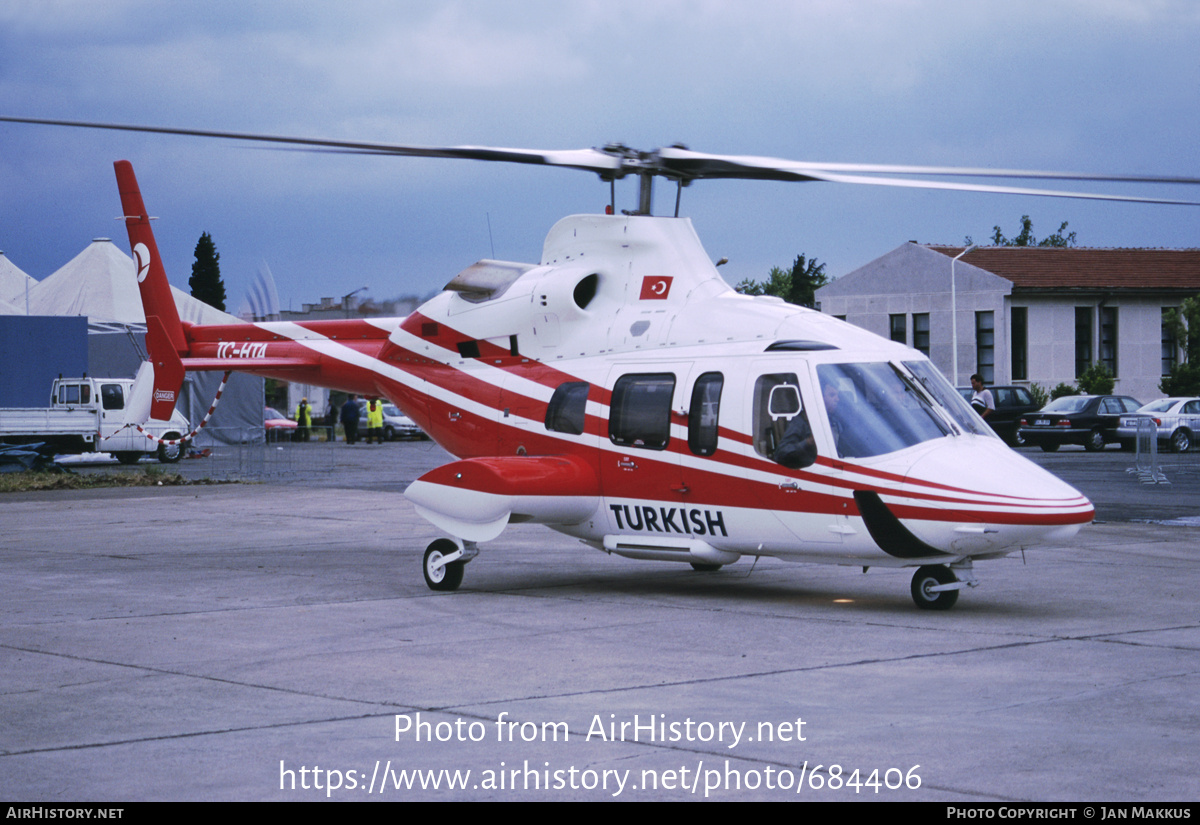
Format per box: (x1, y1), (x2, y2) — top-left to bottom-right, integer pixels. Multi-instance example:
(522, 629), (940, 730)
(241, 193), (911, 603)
(896, 436), (1096, 553)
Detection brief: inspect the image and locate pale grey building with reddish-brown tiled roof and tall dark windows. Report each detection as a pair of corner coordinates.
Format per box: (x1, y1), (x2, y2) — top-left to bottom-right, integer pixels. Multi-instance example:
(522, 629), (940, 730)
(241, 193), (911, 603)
(816, 242), (1200, 402)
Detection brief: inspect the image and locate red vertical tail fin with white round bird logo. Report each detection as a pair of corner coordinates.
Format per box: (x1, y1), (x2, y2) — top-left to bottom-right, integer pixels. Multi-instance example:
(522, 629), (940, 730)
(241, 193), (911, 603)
(113, 161), (187, 423)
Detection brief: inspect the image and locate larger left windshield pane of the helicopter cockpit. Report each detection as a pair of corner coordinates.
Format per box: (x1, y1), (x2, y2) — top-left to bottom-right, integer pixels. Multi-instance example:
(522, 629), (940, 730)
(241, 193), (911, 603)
(817, 361), (961, 458)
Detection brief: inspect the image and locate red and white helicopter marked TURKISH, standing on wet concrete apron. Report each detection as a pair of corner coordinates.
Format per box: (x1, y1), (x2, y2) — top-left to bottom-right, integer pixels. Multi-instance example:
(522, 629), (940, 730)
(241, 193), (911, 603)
(0, 118), (1200, 609)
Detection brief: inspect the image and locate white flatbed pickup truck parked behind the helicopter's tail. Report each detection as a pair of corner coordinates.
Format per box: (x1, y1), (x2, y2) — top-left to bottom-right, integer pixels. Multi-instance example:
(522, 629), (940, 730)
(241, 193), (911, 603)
(0, 378), (188, 464)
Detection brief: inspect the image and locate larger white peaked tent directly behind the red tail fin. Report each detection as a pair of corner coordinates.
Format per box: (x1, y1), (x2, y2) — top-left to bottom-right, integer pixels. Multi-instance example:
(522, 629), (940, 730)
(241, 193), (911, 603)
(27, 237), (241, 324)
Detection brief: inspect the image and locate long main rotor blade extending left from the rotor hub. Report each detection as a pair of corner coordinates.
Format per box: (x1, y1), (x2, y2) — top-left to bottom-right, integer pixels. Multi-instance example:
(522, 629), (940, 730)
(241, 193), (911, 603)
(0, 116), (620, 174)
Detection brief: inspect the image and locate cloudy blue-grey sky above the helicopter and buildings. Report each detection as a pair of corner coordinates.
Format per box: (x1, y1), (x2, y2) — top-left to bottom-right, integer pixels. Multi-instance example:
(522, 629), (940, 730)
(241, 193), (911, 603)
(0, 0), (1200, 309)
